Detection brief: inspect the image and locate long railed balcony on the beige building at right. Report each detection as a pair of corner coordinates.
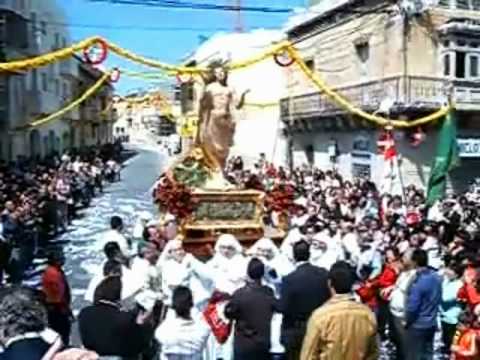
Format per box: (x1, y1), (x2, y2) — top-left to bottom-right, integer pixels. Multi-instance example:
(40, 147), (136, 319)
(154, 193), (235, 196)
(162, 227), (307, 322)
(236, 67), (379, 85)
(281, 76), (480, 121)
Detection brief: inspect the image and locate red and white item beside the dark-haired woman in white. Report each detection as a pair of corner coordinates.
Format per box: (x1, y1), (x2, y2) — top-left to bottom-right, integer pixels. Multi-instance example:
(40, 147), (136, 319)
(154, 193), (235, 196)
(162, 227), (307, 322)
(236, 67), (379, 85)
(203, 291), (232, 344)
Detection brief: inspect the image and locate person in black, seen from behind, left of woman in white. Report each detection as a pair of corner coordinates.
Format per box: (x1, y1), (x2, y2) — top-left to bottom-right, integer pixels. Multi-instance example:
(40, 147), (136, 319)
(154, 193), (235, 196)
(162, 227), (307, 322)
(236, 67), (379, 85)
(78, 276), (154, 358)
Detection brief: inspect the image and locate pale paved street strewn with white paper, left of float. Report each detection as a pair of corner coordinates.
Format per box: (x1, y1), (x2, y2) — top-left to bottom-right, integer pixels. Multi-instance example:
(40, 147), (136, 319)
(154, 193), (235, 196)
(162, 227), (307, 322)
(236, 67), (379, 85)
(22, 148), (164, 313)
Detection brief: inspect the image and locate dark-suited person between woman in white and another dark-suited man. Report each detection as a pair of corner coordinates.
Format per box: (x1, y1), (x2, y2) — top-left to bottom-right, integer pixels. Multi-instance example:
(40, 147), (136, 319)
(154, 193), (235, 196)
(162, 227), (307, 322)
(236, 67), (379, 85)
(225, 258), (278, 360)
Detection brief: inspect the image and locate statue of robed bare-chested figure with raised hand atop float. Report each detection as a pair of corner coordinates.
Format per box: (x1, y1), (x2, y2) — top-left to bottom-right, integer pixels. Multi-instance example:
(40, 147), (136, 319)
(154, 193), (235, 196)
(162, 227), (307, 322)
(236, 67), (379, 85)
(196, 61), (249, 173)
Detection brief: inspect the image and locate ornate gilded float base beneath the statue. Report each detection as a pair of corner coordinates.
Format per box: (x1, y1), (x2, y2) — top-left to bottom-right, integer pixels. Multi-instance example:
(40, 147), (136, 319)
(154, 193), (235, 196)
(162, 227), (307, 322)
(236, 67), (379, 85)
(182, 190), (265, 253)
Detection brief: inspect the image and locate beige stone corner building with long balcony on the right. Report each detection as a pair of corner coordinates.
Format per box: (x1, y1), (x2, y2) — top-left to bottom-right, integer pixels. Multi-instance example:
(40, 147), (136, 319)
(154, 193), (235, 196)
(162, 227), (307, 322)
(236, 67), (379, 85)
(281, 0), (480, 190)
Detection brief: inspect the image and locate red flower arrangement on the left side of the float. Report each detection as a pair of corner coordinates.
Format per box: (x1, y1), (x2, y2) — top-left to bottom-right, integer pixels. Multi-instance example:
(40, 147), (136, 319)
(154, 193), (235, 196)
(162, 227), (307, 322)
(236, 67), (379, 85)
(153, 174), (195, 219)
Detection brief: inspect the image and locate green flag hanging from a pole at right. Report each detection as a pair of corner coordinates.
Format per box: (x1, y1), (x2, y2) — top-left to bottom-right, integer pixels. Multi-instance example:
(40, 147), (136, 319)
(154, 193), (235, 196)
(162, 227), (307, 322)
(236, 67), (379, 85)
(427, 110), (460, 206)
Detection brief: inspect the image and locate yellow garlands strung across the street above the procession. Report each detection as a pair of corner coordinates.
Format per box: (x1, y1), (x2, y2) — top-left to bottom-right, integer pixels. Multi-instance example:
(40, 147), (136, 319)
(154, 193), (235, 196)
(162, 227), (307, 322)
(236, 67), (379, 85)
(0, 36), (452, 128)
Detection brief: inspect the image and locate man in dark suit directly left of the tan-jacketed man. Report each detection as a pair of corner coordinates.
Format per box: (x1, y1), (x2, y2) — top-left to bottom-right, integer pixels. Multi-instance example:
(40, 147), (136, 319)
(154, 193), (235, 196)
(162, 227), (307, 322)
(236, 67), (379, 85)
(280, 241), (330, 360)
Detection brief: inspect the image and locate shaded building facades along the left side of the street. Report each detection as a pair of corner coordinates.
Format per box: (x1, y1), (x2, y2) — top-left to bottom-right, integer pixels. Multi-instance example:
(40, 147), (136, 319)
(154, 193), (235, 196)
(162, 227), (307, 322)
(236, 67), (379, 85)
(0, 0), (114, 160)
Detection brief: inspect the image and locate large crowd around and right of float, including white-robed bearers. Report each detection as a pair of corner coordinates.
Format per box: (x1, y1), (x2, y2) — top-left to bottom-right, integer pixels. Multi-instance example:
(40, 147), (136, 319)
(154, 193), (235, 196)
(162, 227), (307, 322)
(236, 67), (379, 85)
(0, 153), (480, 360)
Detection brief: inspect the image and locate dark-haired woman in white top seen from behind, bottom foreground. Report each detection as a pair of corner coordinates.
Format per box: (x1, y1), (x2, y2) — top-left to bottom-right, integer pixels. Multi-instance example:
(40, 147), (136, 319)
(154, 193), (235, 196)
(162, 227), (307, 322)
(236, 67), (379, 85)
(155, 286), (211, 360)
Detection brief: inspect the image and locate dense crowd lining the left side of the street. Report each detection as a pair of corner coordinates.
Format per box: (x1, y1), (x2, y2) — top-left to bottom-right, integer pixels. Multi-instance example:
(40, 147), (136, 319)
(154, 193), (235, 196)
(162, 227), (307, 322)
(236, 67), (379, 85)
(0, 144), (121, 284)
